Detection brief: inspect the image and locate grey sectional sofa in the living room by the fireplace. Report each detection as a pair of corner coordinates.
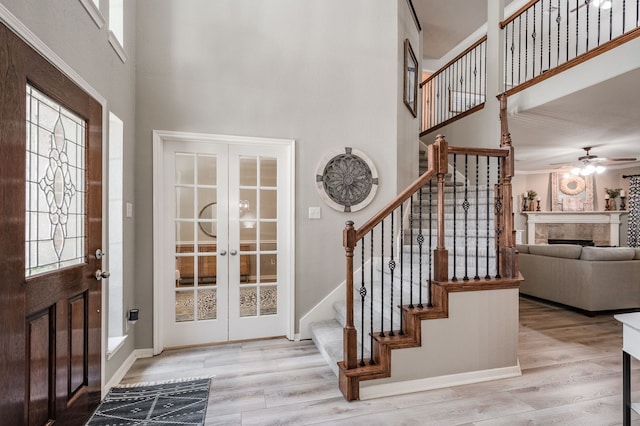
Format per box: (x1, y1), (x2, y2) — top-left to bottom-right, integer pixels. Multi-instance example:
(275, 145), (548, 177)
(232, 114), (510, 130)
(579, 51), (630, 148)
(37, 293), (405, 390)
(516, 244), (640, 315)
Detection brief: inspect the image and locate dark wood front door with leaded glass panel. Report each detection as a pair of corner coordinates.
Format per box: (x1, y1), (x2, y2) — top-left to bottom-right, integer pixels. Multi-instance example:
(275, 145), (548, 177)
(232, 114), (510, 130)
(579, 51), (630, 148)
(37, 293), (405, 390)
(0, 25), (102, 425)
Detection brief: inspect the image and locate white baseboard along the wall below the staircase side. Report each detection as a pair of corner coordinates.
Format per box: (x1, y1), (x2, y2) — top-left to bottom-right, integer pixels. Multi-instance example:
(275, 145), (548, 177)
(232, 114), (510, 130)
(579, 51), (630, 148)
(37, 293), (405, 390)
(360, 361), (522, 400)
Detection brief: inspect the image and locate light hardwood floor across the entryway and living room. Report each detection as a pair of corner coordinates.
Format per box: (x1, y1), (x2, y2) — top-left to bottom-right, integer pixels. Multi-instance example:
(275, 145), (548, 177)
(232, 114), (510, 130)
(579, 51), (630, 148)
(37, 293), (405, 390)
(122, 299), (640, 426)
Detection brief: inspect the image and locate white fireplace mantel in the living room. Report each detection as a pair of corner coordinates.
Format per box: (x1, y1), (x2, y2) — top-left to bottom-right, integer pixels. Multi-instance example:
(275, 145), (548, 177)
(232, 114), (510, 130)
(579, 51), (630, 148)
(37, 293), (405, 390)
(522, 210), (628, 246)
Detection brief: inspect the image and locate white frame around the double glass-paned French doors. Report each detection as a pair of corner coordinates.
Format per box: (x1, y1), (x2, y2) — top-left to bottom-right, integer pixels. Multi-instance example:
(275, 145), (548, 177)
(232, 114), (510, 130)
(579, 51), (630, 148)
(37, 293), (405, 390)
(153, 130), (296, 355)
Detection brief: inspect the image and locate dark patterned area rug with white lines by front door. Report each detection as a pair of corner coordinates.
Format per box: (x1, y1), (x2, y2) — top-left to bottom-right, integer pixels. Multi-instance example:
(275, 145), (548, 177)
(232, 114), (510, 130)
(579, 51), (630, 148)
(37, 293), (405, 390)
(87, 379), (211, 426)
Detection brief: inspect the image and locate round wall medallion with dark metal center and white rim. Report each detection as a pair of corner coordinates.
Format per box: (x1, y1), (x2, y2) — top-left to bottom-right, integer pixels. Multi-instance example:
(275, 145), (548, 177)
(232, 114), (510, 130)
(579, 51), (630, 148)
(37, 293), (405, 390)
(316, 148), (378, 212)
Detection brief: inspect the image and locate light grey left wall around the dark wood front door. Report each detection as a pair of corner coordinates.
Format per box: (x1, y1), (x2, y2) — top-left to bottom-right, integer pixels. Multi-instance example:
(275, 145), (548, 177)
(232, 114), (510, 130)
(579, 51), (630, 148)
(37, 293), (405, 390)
(0, 0), (136, 381)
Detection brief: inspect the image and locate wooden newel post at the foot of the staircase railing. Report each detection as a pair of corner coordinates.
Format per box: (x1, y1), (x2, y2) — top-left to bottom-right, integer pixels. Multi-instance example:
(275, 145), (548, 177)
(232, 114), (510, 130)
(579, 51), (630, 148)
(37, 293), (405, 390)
(342, 221), (358, 369)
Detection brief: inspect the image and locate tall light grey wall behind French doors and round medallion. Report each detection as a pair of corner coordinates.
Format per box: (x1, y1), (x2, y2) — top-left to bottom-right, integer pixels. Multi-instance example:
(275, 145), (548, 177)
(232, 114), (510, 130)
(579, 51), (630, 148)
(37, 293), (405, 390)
(136, 0), (417, 347)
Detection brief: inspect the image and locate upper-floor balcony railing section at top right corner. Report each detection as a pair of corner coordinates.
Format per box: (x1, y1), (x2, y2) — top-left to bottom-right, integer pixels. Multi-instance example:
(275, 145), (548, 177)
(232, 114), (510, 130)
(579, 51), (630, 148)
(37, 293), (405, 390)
(500, 0), (640, 95)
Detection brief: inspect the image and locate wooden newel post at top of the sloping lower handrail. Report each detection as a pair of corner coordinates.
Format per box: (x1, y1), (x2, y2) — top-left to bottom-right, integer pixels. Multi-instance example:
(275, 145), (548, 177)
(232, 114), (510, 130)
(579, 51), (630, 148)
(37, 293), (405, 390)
(433, 135), (449, 282)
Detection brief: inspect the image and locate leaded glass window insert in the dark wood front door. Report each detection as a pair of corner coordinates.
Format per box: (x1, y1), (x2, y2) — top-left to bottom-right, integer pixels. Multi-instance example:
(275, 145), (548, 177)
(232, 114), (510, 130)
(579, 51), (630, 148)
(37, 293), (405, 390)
(25, 85), (86, 277)
